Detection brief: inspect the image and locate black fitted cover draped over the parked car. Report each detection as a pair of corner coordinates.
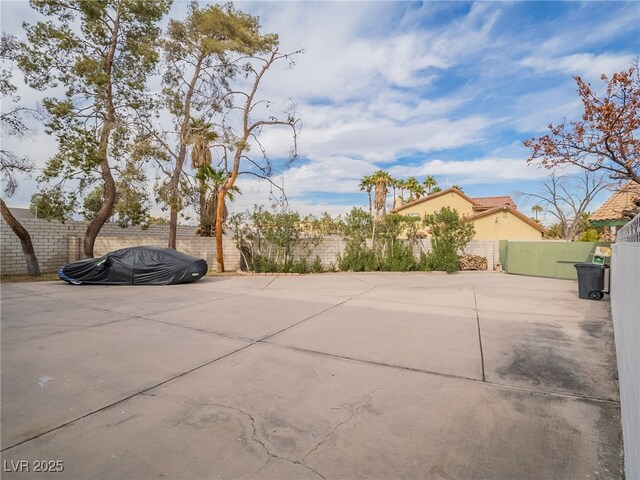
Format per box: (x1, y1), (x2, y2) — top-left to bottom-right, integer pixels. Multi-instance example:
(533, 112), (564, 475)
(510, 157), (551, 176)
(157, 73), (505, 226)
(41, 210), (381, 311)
(58, 247), (208, 285)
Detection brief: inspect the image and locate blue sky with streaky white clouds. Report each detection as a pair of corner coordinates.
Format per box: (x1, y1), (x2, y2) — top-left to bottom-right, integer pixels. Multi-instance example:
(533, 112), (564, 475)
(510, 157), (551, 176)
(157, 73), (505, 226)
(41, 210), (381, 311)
(0, 0), (640, 221)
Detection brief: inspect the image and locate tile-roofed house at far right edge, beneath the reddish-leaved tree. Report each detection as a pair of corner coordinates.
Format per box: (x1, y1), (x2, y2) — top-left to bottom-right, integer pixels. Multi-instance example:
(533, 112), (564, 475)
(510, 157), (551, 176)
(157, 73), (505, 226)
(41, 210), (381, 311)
(589, 181), (640, 236)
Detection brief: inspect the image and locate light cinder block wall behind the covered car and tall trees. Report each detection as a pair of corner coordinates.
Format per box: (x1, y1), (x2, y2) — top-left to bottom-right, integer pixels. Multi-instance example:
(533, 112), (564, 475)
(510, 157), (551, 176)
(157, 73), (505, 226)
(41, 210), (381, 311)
(0, 219), (240, 275)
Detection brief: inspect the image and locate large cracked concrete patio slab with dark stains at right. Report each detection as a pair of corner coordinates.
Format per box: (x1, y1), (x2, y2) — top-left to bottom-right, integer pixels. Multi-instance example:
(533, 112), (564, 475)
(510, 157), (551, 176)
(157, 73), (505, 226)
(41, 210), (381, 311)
(1, 272), (623, 480)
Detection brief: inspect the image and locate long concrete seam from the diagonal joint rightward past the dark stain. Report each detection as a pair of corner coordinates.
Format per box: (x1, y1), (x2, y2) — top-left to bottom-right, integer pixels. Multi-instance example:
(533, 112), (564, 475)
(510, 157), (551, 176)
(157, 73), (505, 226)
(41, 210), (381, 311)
(254, 340), (620, 405)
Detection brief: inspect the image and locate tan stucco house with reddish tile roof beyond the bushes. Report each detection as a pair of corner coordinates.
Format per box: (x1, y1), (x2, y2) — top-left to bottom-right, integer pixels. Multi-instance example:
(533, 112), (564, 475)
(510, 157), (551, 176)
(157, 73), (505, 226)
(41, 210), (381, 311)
(392, 187), (546, 240)
